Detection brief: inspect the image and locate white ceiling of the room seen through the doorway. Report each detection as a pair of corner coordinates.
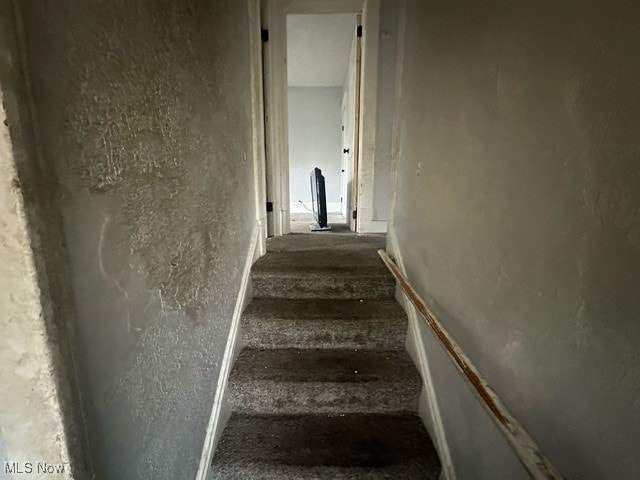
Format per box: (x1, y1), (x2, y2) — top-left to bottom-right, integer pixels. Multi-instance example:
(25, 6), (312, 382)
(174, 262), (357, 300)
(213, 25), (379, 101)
(287, 13), (356, 87)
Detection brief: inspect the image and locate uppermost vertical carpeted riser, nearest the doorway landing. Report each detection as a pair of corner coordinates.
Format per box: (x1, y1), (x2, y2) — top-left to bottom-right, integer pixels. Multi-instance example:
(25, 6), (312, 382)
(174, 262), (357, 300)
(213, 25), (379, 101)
(252, 275), (395, 300)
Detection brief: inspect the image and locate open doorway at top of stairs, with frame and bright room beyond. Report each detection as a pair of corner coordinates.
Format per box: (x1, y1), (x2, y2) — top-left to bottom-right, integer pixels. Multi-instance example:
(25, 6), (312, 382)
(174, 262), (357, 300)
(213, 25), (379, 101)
(262, 0), (386, 236)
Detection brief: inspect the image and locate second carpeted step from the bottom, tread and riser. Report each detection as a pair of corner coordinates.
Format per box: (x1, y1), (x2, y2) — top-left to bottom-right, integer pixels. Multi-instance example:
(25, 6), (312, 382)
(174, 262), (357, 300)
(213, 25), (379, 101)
(229, 349), (421, 414)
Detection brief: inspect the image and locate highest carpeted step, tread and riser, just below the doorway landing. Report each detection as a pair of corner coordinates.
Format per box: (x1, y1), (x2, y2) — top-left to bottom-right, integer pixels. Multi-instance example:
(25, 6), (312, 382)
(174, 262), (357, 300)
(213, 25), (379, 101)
(251, 250), (395, 300)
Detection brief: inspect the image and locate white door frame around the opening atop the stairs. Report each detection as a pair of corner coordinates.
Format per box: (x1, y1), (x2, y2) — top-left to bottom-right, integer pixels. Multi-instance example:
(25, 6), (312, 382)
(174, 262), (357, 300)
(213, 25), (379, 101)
(262, 0), (380, 237)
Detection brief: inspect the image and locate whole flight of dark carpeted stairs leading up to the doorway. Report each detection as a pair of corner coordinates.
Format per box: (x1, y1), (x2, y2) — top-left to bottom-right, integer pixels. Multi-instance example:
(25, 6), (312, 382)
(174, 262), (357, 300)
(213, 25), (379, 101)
(212, 233), (440, 480)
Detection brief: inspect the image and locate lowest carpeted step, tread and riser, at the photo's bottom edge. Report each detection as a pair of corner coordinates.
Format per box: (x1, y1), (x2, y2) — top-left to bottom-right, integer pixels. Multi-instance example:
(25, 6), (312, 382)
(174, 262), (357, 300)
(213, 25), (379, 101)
(211, 414), (440, 480)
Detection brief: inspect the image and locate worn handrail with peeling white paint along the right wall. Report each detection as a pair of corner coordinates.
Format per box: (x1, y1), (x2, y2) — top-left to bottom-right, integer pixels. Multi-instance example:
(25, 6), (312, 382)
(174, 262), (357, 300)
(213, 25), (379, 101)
(378, 250), (562, 480)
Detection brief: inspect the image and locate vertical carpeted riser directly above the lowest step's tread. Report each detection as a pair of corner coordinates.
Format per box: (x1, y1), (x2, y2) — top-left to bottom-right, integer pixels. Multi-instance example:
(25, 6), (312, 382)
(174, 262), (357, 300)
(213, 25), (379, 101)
(230, 381), (420, 415)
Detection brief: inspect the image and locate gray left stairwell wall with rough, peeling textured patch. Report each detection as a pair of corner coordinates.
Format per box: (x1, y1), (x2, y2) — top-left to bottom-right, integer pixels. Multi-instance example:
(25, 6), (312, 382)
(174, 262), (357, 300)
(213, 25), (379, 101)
(15, 0), (255, 479)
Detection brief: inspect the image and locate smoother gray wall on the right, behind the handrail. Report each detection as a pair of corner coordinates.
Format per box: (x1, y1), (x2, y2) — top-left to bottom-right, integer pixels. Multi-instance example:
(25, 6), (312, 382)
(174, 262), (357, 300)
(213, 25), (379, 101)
(394, 0), (640, 479)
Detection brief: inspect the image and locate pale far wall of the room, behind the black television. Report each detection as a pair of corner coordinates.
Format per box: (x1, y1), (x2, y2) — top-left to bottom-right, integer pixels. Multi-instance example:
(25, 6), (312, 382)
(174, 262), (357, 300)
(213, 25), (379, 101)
(288, 87), (342, 211)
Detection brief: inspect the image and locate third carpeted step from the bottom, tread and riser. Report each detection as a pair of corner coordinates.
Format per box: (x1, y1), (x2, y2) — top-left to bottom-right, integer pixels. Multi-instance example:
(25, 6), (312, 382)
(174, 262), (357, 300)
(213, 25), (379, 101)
(242, 299), (407, 350)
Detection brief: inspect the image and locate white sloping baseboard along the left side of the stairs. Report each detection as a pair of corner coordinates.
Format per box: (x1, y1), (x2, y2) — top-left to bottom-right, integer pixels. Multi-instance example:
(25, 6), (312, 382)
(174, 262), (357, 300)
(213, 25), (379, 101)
(196, 225), (263, 480)
